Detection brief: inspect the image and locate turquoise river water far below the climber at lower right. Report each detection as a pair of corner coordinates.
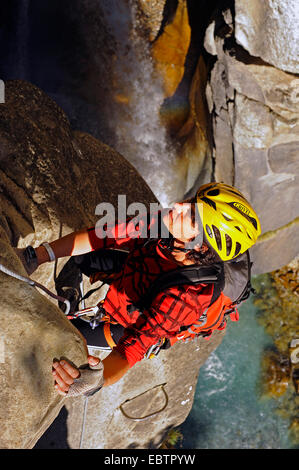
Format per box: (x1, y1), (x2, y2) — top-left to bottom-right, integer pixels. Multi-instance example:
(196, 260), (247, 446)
(180, 299), (293, 449)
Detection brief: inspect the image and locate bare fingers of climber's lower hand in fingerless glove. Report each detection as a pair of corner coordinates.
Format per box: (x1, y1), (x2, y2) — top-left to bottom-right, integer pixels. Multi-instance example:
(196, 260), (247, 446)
(52, 356), (100, 396)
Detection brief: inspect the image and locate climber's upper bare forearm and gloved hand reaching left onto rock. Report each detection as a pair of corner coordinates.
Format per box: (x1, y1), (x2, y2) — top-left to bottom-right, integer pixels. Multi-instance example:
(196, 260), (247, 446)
(35, 229), (92, 265)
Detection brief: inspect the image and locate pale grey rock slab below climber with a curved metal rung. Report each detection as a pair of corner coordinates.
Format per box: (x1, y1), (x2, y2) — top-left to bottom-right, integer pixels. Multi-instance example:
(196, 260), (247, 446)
(67, 331), (223, 449)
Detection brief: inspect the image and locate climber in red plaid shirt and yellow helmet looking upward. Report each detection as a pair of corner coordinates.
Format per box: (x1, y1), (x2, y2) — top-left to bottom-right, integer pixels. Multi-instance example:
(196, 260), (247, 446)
(17, 183), (261, 395)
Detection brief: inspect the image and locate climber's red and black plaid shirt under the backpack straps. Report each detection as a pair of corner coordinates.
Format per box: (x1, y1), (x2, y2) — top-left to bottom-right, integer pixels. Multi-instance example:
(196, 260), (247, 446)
(89, 213), (213, 367)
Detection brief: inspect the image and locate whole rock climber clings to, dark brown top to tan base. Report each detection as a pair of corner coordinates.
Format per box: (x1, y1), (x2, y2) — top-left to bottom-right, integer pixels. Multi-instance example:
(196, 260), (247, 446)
(0, 81), (222, 448)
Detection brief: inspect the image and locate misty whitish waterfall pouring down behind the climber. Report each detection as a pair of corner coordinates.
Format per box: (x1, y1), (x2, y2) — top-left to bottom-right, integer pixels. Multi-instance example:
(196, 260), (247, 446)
(99, 0), (179, 206)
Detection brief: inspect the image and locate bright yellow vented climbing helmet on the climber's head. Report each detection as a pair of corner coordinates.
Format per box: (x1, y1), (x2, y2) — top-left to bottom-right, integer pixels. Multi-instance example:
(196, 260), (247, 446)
(196, 183), (261, 261)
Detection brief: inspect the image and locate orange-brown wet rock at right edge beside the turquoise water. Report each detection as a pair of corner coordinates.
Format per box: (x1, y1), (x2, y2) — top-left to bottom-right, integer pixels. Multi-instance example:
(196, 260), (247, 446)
(254, 257), (299, 444)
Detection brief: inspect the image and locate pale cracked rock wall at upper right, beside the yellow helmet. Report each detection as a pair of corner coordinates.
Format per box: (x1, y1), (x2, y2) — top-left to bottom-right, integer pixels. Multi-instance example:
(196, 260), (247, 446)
(205, 2), (299, 273)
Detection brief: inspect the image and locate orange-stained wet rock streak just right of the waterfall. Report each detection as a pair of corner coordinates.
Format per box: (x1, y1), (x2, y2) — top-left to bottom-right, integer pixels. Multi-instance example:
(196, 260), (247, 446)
(151, 0), (212, 198)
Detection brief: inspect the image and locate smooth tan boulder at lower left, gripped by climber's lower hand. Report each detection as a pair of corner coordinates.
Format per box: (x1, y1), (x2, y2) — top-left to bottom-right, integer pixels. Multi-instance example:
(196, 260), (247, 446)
(0, 230), (87, 449)
